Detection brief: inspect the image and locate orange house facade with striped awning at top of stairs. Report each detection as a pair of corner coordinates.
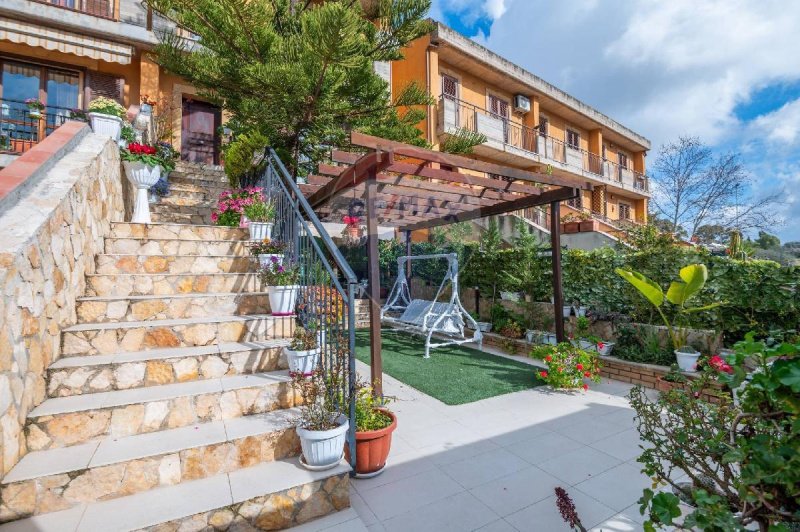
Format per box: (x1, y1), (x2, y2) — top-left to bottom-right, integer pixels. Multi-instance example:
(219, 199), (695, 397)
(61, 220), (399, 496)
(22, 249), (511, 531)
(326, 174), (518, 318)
(0, 0), (221, 166)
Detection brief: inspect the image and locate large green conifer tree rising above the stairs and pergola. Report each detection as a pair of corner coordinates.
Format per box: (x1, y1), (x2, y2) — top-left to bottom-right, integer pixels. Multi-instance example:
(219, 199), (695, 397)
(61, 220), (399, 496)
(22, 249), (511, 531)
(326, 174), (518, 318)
(144, 0), (440, 174)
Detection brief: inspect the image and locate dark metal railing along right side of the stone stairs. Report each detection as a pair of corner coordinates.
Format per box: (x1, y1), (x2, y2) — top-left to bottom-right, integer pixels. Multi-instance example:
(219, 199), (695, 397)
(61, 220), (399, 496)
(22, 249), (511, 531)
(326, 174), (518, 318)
(259, 149), (358, 467)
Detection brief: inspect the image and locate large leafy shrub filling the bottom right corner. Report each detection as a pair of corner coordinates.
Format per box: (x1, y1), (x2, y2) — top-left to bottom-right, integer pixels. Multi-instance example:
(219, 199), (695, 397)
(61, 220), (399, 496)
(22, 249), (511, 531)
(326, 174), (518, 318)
(629, 333), (800, 531)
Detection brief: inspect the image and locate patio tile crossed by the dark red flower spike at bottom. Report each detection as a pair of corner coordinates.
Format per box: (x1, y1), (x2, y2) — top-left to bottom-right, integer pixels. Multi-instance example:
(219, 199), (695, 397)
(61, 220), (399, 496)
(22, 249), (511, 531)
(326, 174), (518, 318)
(505, 489), (616, 532)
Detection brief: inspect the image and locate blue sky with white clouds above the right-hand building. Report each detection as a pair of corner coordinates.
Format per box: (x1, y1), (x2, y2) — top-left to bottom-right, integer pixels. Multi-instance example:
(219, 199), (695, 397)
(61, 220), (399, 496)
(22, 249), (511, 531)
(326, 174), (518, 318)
(431, 0), (800, 241)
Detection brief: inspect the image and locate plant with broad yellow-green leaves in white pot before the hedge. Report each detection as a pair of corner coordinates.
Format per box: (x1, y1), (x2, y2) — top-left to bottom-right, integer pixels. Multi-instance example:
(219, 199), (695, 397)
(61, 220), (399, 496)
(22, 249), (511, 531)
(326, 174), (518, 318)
(614, 264), (721, 349)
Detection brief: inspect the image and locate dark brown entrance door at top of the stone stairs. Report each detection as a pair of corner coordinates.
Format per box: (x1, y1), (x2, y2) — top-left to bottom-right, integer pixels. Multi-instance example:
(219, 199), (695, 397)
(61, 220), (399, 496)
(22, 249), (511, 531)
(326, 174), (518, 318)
(181, 99), (220, 164)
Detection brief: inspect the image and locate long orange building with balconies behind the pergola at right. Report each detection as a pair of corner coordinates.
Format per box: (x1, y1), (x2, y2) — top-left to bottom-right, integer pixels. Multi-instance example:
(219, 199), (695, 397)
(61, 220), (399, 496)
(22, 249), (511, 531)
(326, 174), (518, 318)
(391, 22), (650, 233)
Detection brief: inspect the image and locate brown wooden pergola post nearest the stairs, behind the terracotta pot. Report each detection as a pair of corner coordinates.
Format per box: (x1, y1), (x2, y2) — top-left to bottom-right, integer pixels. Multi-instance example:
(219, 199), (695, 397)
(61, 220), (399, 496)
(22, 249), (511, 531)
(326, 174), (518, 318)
(366, 166), (383, 397)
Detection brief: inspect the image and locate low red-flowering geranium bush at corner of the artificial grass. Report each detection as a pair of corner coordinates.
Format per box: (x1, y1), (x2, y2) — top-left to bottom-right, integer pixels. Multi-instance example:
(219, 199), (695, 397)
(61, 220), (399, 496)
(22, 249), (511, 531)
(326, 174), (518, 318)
(537, 342), (600, 390)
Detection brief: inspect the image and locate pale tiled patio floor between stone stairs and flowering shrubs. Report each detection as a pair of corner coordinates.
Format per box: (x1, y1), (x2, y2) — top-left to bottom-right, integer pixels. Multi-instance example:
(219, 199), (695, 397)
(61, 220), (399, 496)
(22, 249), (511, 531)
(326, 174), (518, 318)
(290, 344), (650, 532)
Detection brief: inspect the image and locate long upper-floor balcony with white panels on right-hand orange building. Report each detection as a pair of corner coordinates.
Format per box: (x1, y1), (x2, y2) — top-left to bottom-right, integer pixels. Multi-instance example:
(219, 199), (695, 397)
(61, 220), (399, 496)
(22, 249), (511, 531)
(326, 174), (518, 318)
(439, 96), (650, 195)
